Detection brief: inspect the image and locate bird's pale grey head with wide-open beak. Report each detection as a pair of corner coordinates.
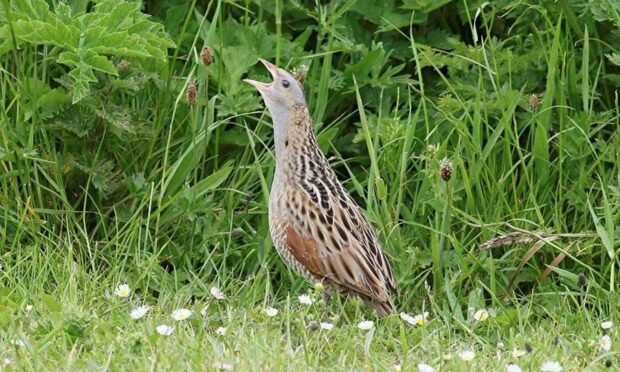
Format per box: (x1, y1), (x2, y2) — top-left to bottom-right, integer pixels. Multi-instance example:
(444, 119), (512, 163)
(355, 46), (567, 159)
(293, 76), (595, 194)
(244, 58), (306, 121)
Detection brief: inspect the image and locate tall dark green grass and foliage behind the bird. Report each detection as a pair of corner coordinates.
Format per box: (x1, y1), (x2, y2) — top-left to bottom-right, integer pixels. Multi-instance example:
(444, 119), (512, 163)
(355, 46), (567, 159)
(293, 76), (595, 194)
(0, 0), (620, 313)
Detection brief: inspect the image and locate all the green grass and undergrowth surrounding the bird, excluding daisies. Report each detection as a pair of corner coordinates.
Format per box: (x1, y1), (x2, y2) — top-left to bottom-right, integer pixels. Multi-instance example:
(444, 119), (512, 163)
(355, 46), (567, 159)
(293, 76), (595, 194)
(0, 0), (620, 371)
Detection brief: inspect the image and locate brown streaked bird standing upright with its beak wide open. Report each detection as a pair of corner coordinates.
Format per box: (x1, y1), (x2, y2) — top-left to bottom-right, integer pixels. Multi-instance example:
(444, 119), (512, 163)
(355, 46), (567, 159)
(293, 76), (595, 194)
(244, 58), (399, 316)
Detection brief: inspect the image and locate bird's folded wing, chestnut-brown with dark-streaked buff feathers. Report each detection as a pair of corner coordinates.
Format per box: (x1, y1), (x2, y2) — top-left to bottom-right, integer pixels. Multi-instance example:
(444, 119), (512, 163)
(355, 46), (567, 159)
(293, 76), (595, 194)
(286, 177), (398, 302)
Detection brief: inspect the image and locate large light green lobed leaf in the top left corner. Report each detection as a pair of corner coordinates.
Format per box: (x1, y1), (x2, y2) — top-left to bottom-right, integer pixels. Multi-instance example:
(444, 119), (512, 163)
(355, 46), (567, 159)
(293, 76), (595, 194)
(0, 0), (175, 103)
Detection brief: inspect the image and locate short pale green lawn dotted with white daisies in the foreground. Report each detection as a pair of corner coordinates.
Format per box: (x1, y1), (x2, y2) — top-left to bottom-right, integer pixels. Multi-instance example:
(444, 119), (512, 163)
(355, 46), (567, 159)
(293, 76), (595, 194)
(2, 243), (618, 370)
